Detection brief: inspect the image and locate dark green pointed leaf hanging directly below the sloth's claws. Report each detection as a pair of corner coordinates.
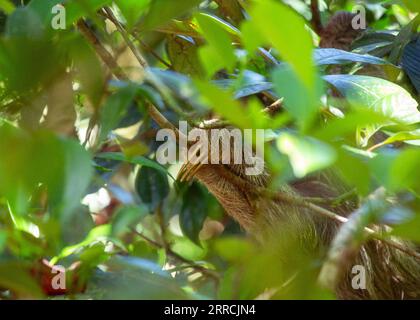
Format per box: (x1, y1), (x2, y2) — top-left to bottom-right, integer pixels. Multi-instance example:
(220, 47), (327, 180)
(179, 183), (208, 245)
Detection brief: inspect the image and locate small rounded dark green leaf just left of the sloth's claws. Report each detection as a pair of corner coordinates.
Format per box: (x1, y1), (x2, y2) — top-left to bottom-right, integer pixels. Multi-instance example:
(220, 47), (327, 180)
(135, 166), (169, 212)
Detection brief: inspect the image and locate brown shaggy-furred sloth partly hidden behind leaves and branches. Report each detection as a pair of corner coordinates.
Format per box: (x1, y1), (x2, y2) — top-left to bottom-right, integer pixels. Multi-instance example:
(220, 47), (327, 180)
(174, 12), (420, 299)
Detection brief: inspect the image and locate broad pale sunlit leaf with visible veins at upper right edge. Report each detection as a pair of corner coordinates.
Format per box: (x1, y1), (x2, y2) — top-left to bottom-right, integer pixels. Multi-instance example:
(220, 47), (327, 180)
(324, 75), (420, 146)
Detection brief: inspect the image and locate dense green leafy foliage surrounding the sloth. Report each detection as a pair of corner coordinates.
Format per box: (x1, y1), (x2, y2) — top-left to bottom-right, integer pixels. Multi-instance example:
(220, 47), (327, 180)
(0, 0), (420, 299)
